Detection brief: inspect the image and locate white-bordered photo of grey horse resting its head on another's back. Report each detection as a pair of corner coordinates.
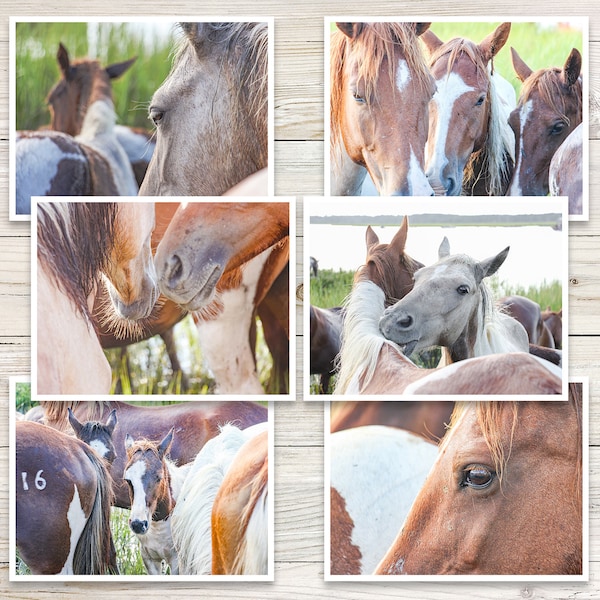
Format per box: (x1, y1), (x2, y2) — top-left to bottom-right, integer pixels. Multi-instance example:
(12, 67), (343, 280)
(303, 198), (568, 400)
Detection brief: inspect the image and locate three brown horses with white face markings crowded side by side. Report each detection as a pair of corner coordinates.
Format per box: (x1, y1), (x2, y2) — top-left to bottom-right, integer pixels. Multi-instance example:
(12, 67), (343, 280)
(330, 22), (583, 214)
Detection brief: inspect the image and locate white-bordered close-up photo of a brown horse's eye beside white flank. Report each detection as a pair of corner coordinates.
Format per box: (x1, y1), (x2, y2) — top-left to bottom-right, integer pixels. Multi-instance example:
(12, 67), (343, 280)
(325, 378), (589, 581)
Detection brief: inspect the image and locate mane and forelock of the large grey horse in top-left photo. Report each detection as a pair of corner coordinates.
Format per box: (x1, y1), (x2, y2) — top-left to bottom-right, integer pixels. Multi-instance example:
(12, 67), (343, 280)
(173, 22), (269, 164)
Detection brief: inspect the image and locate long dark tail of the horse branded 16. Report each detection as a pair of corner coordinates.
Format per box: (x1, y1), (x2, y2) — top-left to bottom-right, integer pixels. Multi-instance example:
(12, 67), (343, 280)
(73, 443), (119, 575)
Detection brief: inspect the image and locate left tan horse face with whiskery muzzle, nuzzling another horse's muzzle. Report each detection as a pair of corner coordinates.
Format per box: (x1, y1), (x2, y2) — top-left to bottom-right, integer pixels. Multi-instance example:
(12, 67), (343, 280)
(104, 202), (158, 320)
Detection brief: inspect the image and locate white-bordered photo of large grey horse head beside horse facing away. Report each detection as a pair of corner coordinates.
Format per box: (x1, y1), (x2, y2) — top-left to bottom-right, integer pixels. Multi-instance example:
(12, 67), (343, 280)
(9, 18), (274, 220)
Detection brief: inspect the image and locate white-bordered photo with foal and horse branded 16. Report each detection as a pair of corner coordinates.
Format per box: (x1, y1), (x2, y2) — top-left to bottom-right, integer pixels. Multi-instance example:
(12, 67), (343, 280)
(10, 377), (274, 581)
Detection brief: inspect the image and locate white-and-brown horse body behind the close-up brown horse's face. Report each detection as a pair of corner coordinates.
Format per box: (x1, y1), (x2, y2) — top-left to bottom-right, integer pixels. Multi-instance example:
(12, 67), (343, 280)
(329, 424), (437, 575)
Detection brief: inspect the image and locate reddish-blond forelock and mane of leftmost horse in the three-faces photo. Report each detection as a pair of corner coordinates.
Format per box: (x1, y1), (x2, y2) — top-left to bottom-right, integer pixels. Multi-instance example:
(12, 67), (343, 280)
(330, 22), (431, 146)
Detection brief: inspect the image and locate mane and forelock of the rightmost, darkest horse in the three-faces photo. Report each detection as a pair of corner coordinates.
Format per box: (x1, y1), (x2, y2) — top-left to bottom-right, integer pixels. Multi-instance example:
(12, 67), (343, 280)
(519, 67), (583, 125)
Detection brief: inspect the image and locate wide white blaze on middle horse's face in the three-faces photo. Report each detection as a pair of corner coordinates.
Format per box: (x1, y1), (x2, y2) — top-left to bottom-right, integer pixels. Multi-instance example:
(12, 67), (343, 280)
(426, 73), (475, 180)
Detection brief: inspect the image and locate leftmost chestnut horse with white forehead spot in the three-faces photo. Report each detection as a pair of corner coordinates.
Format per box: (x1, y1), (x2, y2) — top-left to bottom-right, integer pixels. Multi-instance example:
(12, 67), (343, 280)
(330, 23), (435, 196)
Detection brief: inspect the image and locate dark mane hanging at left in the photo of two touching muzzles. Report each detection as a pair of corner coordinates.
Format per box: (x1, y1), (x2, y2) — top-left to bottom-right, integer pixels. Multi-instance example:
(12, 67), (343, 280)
(37, 202), (118, 330)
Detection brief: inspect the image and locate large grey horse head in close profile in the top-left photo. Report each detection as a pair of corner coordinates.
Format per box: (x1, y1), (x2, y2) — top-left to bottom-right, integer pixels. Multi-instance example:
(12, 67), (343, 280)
(140, 22), (269, 196)
